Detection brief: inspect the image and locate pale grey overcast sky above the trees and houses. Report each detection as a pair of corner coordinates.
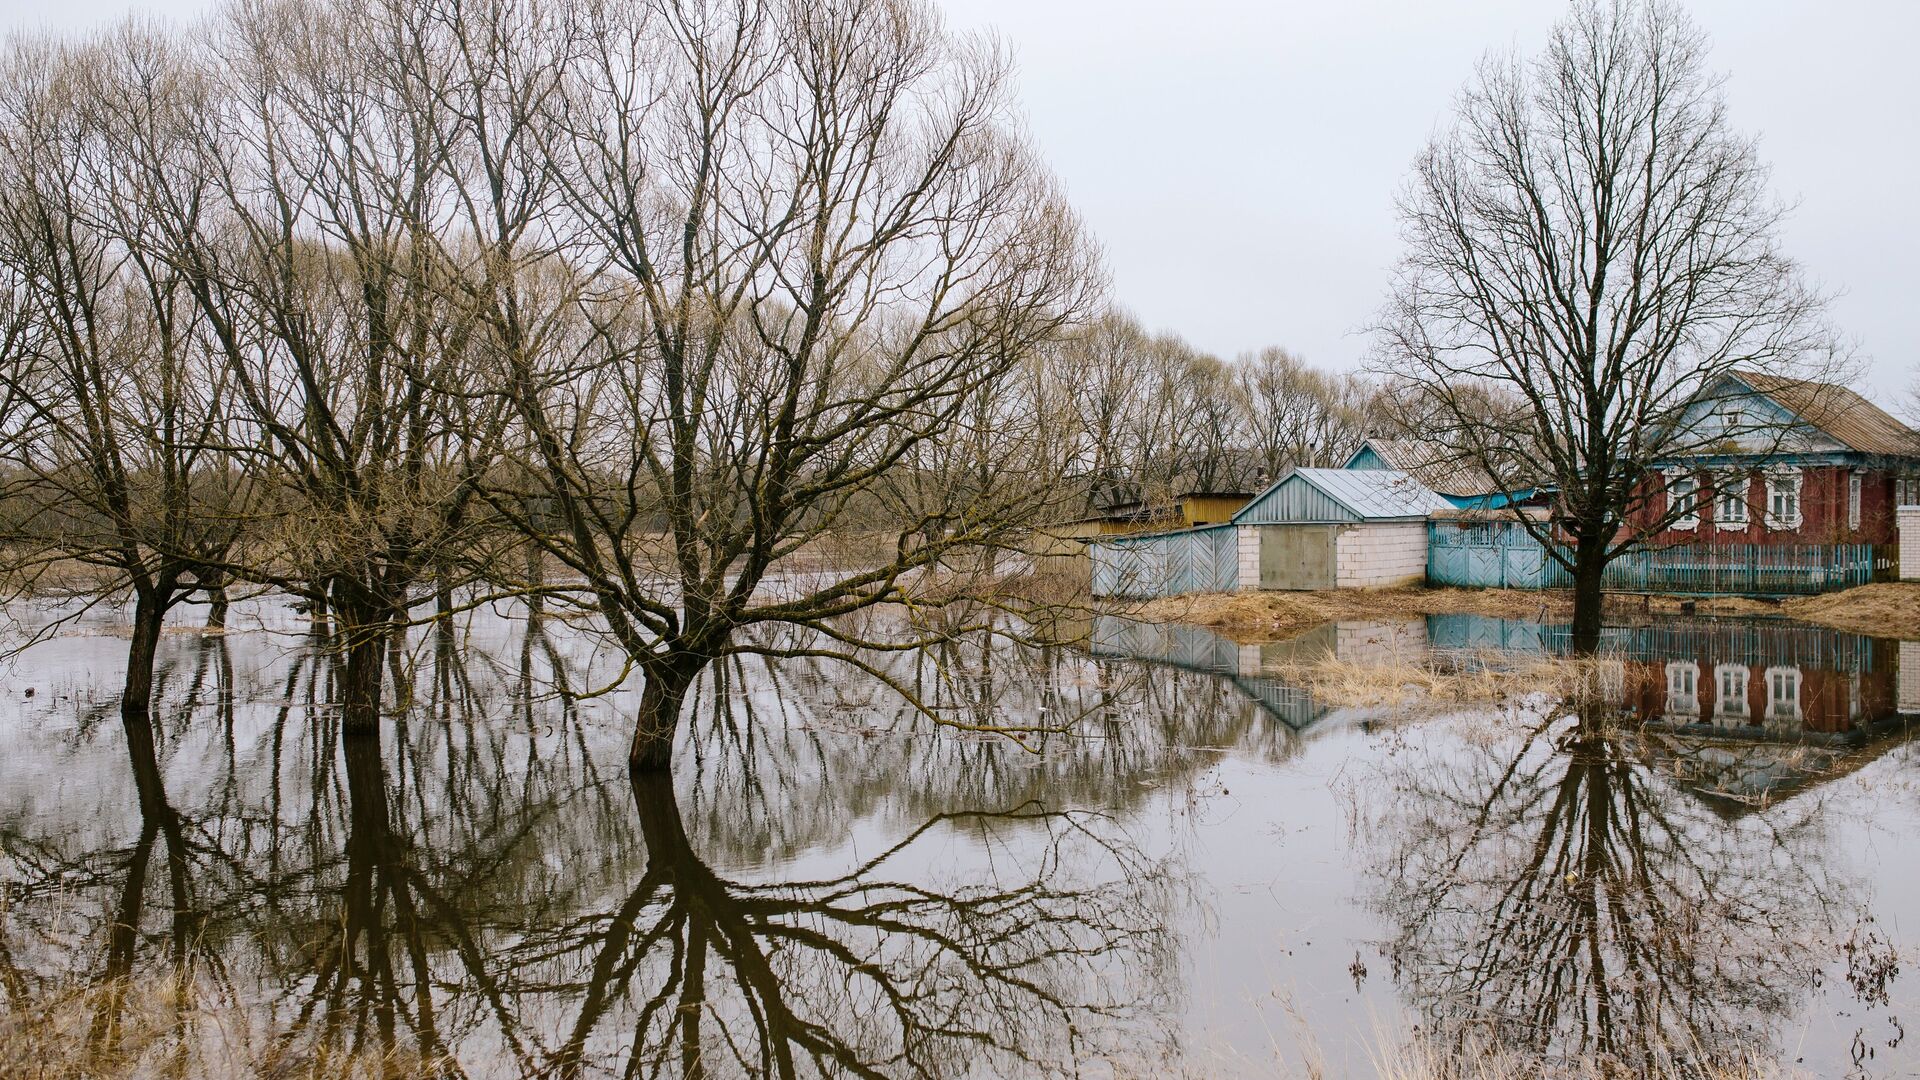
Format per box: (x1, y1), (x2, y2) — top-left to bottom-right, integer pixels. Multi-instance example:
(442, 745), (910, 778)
(0, 0), (1920, 395)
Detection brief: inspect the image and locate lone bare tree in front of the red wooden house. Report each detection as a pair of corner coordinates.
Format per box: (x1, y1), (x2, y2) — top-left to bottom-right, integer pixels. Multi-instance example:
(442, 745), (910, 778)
(1379, 0), (1830, 646)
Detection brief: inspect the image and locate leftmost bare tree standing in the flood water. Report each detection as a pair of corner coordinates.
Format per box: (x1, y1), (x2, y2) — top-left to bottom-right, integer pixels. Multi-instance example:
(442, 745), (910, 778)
(0, 29), (253, 721)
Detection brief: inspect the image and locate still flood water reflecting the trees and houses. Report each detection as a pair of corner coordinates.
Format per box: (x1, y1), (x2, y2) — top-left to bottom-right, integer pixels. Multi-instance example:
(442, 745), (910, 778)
(0, 591), (1920, 1076)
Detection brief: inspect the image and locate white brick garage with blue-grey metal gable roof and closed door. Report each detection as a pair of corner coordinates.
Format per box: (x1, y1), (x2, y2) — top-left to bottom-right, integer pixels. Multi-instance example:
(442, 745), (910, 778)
(1233, 469), (1452, 590)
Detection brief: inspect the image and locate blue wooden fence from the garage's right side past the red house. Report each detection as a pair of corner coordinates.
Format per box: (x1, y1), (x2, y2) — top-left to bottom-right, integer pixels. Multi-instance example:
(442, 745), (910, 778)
(1427, 521), (1893, 596)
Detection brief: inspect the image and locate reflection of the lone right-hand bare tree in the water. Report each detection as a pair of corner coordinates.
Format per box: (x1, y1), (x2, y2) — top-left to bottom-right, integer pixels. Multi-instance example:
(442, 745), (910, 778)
(1369, 691), (1860, 1076)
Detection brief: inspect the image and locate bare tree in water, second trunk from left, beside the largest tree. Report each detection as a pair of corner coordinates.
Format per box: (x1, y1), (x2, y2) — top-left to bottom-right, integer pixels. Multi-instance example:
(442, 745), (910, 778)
(144, 2), (505, 732)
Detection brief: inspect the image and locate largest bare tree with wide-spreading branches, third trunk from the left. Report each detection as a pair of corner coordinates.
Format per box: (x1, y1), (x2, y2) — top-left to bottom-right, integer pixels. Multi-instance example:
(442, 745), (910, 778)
(493, 0), (1096, 771)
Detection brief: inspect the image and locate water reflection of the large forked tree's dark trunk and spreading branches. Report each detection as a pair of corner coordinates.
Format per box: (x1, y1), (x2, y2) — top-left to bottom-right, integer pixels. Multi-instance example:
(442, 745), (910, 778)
(536, 778), (1164, 1076)
